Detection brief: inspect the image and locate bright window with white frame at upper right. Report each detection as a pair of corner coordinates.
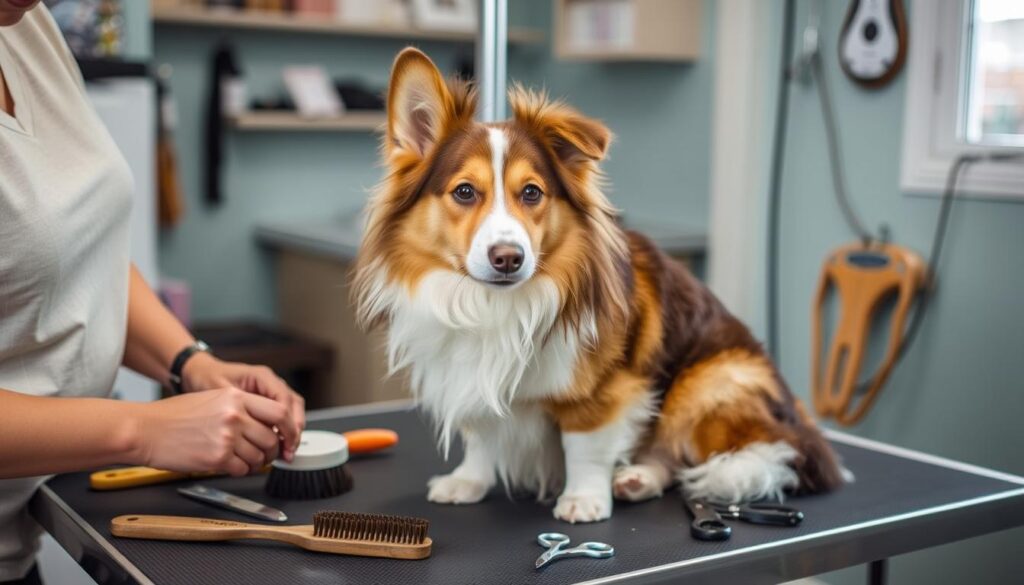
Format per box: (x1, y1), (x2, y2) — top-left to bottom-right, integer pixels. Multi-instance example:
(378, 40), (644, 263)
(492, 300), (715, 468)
(901, 0), (1024, 199)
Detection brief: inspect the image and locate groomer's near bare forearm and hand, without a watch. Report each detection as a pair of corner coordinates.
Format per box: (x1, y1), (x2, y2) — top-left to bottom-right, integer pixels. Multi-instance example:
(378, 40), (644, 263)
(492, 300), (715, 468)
(0, 388), (289, 478)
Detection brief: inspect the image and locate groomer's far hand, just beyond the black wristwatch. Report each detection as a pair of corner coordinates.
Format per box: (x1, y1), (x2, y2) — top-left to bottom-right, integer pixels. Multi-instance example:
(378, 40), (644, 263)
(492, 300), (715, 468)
(181, 352), (306, 461)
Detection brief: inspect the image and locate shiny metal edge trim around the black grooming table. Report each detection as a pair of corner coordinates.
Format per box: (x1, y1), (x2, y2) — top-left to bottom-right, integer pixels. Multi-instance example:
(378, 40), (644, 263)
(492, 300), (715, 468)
(30, 399), (1024, 585)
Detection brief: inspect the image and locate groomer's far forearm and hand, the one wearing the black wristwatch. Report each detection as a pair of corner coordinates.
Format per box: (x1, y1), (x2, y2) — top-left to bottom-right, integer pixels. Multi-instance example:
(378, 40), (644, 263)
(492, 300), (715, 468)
(124, 266), (305, 459)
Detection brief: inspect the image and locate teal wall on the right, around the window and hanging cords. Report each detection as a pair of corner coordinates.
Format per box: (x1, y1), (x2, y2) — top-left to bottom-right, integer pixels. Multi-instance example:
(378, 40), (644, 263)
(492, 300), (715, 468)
(770, 0), (1024, 584)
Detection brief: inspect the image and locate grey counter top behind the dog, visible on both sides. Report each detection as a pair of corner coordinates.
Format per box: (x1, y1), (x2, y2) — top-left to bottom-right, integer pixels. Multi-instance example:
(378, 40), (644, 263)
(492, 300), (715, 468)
(256, 214), (708, 261)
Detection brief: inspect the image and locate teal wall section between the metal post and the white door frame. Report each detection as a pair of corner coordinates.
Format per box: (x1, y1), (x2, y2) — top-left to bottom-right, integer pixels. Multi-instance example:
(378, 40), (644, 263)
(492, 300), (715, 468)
(509, 0), (715, 228)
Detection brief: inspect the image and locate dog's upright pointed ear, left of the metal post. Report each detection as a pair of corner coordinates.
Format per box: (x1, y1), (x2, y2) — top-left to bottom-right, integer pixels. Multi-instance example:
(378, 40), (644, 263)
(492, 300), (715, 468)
(386, 47), (473, 157)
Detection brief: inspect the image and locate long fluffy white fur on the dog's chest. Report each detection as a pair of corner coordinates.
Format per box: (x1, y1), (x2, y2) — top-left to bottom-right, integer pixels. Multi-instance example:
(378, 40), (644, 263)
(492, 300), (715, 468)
(380, 271), (593, 452)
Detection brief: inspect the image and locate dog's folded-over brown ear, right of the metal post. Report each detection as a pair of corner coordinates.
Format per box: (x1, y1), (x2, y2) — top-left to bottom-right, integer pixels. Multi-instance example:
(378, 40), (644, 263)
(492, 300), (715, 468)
(509, 86), (611, 168)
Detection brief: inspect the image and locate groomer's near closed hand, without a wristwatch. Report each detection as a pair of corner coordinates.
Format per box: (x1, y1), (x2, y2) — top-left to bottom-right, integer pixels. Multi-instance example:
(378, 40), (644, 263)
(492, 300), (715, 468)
(135, 388), (294, 475)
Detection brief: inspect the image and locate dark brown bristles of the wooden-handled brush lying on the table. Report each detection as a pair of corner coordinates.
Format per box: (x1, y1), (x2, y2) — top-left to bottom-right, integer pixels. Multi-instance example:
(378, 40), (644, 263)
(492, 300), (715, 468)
(313, 511), (430, 544)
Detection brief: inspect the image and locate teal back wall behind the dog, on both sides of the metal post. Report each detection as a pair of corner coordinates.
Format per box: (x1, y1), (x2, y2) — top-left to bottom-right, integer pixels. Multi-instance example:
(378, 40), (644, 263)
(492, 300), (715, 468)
(154, 0), (714, 320)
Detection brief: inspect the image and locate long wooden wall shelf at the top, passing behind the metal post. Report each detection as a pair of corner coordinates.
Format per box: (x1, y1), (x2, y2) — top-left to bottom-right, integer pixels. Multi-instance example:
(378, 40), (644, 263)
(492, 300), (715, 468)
(153, 6), (544, 43)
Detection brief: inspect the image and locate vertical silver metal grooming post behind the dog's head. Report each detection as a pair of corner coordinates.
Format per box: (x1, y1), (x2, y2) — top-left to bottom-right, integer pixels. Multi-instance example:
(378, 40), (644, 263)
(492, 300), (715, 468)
(476, 0), (509, 122)
